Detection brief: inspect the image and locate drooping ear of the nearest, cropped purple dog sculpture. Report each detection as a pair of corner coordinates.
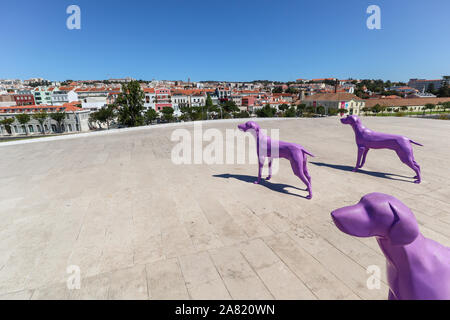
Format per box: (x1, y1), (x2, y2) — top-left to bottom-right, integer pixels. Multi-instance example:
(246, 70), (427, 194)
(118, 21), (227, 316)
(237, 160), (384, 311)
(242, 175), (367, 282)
(388, 202), (419, 246)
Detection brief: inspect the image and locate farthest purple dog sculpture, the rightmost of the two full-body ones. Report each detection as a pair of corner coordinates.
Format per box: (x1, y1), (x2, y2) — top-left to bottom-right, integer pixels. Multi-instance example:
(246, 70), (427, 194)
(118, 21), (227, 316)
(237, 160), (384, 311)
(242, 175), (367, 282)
(341, 115), (422, 183)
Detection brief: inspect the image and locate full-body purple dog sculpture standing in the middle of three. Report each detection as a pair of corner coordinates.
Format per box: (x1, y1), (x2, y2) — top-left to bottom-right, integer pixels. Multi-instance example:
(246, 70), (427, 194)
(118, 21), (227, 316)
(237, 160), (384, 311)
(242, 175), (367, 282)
(238, 121), (314, 199)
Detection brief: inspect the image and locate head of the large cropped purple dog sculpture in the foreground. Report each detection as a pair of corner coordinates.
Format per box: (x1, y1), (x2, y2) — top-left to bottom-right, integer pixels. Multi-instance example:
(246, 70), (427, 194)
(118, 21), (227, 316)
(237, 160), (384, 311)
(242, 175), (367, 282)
(331, 193), (419, 245)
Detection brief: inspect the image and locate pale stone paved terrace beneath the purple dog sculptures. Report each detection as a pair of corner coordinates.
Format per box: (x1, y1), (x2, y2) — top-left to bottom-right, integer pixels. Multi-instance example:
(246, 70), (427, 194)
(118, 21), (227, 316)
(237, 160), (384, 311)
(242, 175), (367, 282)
(0, 117), (450, 299)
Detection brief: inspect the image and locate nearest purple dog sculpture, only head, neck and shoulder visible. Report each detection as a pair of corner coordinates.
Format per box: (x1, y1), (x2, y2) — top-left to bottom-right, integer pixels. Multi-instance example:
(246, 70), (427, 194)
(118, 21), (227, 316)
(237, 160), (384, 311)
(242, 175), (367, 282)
(331, 193), (450, 300)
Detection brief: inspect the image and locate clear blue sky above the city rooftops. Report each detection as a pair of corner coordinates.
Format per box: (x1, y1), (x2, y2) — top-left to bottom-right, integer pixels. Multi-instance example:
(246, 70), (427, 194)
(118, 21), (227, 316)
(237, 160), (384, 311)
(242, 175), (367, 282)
(0, 0), (450, 81)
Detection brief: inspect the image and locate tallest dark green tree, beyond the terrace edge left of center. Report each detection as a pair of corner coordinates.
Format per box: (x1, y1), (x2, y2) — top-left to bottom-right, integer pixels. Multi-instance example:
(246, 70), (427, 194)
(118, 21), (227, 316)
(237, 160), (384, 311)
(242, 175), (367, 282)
(116, 81), (145, 127)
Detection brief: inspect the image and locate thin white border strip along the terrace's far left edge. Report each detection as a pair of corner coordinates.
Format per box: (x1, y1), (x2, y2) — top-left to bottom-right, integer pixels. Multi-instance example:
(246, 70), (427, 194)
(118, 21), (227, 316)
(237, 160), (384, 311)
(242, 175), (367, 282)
(0, 118), (292, 147)
